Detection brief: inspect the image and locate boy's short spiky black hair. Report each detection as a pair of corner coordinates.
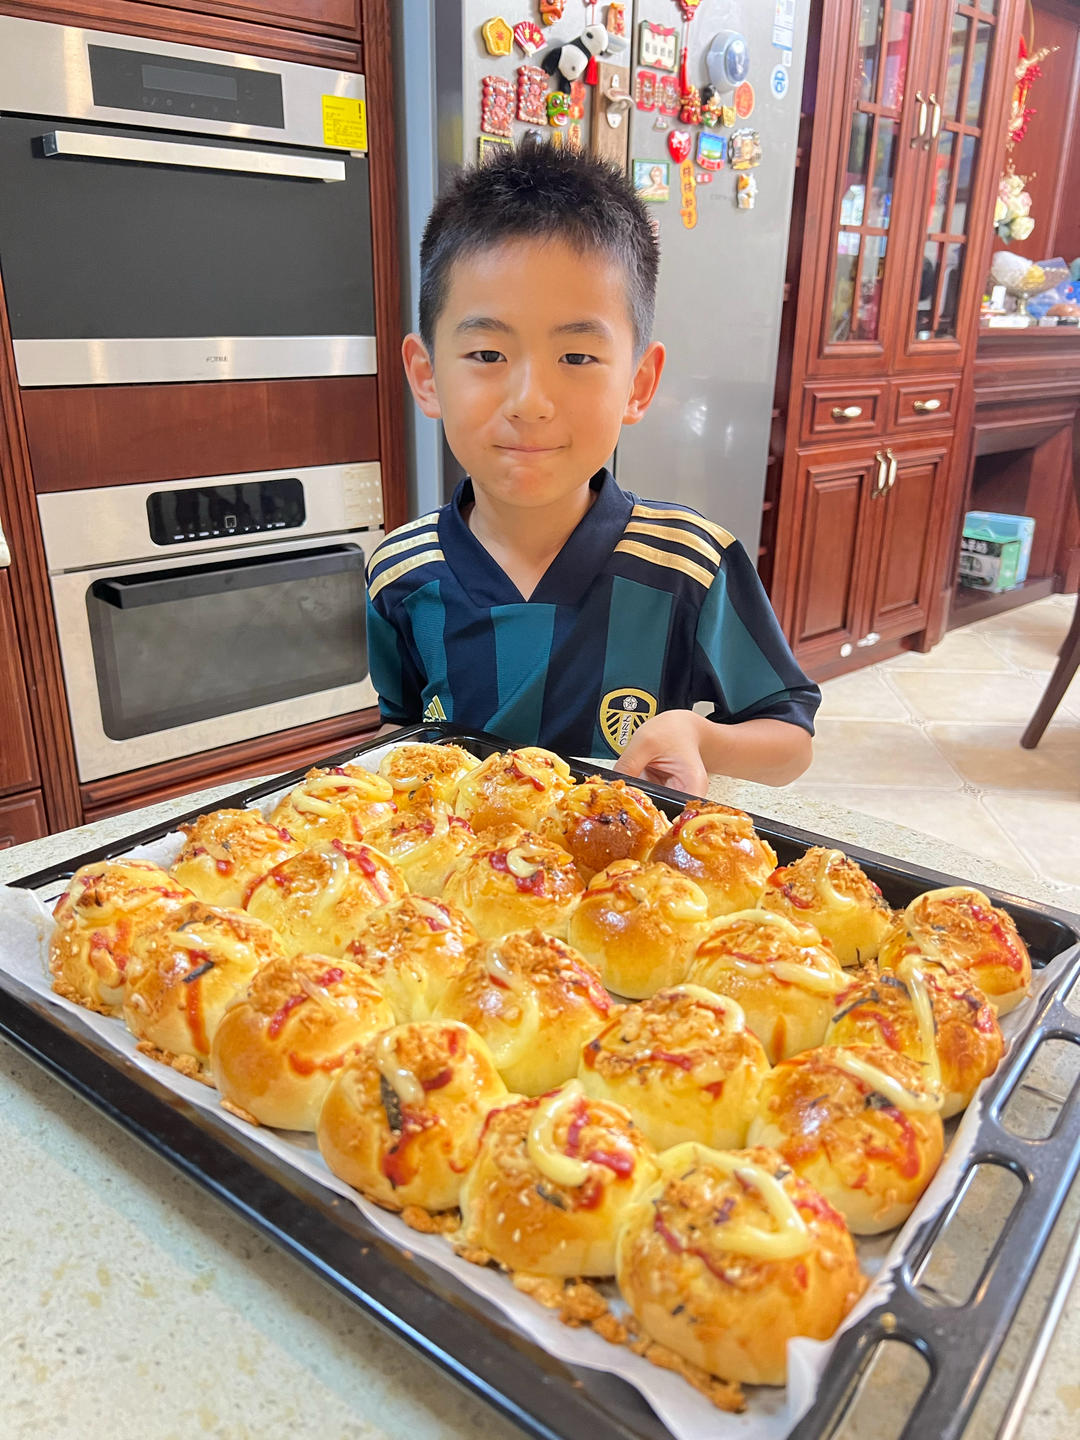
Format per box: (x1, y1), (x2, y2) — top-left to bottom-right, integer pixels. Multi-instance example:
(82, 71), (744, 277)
(420, 138), (660, 356)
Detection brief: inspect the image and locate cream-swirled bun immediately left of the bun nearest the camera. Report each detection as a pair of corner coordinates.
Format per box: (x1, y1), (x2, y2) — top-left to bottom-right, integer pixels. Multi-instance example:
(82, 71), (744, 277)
(461, 1080), (657, 1276)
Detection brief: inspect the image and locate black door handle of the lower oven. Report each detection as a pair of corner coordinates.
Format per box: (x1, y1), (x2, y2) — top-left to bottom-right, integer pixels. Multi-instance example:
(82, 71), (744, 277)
(91, 544), (364, 611)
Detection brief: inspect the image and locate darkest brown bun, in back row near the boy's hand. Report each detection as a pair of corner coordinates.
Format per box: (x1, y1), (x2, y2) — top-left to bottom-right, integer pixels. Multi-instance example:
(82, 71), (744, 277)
(541, 775), (668, 880)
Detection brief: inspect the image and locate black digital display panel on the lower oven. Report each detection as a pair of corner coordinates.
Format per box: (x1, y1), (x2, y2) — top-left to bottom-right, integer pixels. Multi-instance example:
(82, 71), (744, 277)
(147, 477), (305, 544)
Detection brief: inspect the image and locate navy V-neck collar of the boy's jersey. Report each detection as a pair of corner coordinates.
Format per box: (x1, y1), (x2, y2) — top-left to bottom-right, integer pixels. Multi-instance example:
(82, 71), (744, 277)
(439, 469), (634, 605)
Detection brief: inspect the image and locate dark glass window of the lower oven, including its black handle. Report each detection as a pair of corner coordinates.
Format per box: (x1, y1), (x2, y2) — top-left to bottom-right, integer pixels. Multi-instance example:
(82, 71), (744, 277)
(86, 544), (367, 740)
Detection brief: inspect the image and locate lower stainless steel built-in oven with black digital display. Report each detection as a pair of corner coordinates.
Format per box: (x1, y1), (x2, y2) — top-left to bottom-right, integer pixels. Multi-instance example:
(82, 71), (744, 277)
(37, 464), (382, 780)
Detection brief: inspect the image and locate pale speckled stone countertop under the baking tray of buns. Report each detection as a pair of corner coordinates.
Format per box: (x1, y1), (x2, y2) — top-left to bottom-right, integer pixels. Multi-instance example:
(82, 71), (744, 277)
(0, 780), (1080, 1440)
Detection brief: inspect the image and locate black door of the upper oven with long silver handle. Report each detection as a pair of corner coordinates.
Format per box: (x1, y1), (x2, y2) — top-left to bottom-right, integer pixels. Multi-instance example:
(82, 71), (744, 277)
(0, 115), (376, 386)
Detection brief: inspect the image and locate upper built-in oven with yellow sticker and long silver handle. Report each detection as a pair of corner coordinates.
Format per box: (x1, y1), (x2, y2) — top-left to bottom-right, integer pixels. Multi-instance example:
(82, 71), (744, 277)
(0, 16), (376, 386)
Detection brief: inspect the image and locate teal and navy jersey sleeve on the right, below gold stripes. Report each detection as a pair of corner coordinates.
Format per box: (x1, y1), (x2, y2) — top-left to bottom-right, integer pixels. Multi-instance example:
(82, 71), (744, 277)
(694, 540), (821, 734)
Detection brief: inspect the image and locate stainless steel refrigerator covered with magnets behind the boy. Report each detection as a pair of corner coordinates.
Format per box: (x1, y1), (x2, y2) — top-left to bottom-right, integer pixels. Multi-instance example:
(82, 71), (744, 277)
(395, 0), (809, 556)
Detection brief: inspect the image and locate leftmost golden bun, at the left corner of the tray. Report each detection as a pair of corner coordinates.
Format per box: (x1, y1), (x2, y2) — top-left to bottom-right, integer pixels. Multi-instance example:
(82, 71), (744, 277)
(49, 860), (194, 1015)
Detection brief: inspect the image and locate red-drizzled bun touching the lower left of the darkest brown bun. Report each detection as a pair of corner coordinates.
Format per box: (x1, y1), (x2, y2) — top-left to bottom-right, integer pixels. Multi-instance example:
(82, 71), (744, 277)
(442, 827), (585, 940)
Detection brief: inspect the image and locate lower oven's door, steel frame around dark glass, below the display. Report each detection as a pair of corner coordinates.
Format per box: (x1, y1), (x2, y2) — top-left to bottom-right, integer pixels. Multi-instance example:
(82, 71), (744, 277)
(52, 531), (382, 780)
